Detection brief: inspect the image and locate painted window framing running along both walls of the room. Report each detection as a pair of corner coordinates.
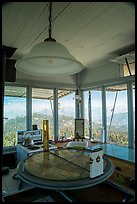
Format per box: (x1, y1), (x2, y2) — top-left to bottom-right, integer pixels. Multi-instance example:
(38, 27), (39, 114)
(4, 76), (135, 148)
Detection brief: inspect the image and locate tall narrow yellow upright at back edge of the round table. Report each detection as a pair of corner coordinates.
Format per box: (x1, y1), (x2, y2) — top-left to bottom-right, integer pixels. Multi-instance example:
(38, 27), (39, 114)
(43, 120), (49, 151)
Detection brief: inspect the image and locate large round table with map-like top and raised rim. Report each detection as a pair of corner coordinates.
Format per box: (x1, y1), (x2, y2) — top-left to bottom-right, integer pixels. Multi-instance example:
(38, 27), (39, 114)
(17, 149), (114, 191)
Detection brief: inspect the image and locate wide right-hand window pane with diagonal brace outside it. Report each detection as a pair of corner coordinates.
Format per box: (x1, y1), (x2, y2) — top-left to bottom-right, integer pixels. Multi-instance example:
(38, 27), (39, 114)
(106, 84), (128, 146)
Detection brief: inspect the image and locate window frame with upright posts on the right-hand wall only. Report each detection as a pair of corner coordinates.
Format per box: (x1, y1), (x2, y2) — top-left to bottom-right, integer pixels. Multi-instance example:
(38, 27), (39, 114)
(82, 76), (135, 148)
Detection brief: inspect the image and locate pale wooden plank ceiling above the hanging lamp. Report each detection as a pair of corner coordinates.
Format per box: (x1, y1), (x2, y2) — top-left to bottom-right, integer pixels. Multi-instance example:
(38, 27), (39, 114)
(2, 2), (135, 69)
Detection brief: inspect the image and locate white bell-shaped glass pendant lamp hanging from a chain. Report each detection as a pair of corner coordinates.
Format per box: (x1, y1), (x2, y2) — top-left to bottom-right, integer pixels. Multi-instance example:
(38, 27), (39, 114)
(15, 2), (84, 76)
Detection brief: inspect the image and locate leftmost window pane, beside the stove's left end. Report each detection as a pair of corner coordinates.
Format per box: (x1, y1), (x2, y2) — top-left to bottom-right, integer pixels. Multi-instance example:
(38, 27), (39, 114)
(3, 86), (26, 146)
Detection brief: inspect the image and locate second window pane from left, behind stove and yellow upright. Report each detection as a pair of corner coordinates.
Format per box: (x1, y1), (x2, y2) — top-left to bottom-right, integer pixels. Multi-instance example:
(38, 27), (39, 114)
(32, 88), (54, 140)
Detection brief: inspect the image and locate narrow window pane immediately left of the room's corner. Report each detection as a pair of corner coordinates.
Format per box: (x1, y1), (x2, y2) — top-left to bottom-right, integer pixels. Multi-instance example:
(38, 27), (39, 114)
(58, 90), (75, 139)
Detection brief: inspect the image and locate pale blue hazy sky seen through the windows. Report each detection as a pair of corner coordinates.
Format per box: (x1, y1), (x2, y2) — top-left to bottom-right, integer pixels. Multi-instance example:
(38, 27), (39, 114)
(4, 91), (135, 119)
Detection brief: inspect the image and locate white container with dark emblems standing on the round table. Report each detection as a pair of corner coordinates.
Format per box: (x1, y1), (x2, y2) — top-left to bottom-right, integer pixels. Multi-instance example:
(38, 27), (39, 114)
(90, 148), (104, 178)
